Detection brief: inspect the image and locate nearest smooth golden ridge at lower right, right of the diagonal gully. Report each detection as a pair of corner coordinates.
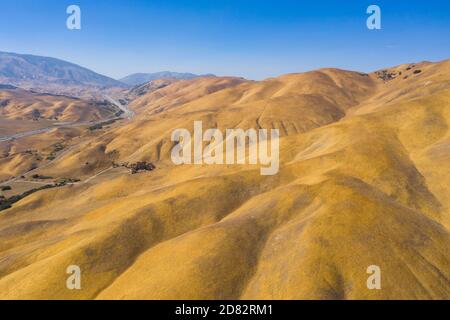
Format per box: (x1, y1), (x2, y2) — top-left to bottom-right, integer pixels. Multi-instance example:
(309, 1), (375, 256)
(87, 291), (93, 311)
(99, 92), (450, 299)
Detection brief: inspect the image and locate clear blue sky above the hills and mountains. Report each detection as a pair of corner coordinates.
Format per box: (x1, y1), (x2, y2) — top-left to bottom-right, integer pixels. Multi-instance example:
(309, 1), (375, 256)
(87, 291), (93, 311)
(0, 0), (450, 79)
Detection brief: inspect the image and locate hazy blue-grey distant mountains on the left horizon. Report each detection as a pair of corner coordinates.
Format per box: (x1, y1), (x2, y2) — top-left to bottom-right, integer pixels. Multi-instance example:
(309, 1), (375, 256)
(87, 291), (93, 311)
(0, 52), (218, 98)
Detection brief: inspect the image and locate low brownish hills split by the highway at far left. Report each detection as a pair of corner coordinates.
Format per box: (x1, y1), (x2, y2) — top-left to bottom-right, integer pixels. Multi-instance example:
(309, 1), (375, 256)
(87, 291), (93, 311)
(0, 87), (123, 182)
